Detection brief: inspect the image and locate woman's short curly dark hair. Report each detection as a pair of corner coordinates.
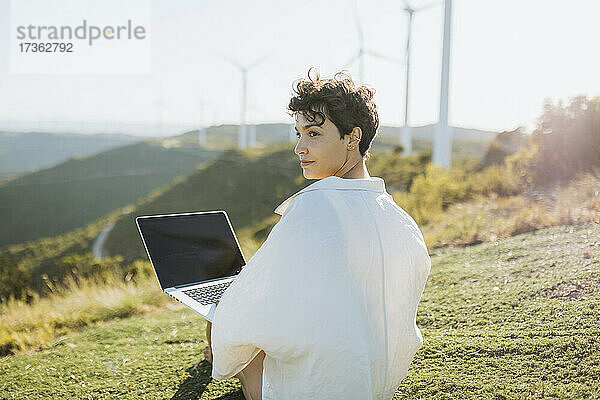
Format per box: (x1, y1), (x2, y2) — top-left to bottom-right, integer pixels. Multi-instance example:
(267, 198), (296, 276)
(288, 67), (379, 159)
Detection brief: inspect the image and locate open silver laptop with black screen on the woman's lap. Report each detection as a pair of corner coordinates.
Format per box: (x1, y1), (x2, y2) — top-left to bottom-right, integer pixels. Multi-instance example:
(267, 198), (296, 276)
(135, 210), (246, 322)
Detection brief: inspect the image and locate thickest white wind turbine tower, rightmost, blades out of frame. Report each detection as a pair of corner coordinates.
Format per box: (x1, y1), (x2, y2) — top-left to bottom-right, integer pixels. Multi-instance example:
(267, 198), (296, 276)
(432, 0), (452, 169)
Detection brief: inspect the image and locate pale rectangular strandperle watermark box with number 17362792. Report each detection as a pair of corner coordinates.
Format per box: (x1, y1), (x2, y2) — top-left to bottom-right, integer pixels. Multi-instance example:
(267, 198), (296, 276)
(9, 0), (151, 74)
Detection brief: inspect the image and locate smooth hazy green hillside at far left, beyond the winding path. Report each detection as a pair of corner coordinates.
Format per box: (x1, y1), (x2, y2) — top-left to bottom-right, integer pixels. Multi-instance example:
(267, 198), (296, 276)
(0, 143), (218, 246)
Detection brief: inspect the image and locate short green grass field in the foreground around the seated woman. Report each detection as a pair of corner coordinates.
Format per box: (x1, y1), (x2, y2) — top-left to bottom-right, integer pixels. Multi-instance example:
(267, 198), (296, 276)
(0, 224), (600, 400)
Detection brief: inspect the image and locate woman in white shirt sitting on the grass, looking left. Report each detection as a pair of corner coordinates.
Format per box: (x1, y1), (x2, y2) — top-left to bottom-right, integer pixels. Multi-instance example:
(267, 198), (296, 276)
(205, 70), (431, 400)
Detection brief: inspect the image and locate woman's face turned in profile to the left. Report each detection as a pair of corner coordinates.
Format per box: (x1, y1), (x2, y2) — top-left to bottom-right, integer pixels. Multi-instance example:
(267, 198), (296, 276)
(294, 113), (358, 179)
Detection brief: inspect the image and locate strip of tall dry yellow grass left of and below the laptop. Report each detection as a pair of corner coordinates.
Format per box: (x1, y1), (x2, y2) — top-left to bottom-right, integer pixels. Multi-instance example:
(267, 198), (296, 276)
(0, 275), (168, 356)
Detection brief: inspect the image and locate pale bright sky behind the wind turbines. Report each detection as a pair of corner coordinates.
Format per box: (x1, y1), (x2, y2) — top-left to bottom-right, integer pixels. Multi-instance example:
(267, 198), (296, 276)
(0, 0), (600, 133)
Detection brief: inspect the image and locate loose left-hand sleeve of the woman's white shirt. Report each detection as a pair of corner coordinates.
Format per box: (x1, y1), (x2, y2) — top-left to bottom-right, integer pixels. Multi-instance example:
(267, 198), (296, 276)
(211, 193), (342, 380)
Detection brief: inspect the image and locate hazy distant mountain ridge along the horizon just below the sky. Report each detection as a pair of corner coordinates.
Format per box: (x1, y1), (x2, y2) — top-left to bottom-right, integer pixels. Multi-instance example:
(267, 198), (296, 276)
(0, 123), (496, 183)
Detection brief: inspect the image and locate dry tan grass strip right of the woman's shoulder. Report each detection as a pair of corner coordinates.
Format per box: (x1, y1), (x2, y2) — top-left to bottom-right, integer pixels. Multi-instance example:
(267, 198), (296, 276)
(418, 174), (600, 248)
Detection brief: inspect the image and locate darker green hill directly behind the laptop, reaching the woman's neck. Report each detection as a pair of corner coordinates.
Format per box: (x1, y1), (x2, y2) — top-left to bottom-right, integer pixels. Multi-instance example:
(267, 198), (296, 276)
(104, 144), (304, 261)
